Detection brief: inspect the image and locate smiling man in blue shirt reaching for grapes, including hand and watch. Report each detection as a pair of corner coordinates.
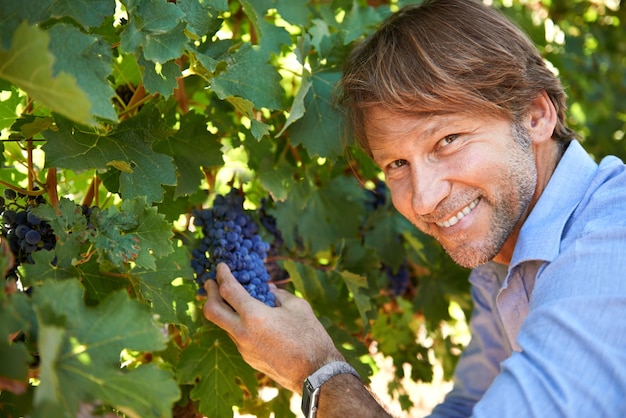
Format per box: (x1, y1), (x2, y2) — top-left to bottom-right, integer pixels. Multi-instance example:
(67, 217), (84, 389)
(204, 0), (626, 418)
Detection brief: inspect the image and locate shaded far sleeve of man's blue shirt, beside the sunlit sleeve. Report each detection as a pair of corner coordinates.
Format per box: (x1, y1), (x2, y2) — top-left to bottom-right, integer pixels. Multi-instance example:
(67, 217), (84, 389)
(429, 263), (510, 418)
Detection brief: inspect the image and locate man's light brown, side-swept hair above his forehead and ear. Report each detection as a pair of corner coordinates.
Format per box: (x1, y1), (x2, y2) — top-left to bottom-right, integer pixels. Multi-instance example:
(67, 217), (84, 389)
(337, 0), (575, 151)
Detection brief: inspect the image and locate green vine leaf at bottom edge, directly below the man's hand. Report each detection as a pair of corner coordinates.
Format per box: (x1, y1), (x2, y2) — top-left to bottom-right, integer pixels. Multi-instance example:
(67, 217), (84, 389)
(177, 324), (258, 418)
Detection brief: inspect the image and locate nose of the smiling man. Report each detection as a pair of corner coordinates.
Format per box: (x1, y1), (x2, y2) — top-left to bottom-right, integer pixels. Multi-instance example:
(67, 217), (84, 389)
(411, 162), (450, 216)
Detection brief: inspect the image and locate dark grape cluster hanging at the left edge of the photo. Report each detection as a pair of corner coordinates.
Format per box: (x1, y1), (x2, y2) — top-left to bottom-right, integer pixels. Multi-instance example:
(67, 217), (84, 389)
(0, 189), (56, 280)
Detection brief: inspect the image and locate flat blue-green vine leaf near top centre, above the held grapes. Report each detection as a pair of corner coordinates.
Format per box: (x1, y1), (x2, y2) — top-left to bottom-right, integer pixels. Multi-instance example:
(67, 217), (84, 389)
(211, 44), (284, 109)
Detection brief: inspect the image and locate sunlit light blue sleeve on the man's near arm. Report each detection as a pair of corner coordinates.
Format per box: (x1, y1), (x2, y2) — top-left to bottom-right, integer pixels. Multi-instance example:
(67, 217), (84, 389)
(474, 224), (626, 418)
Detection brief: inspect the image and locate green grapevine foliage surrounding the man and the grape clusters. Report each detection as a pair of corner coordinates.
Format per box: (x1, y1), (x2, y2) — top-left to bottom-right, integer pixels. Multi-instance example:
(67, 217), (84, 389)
(0, 0), (626, 418)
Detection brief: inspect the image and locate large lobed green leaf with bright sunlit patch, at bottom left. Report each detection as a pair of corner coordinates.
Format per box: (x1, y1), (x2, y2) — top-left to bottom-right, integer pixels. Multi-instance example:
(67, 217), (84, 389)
(33, 280), (180, 417)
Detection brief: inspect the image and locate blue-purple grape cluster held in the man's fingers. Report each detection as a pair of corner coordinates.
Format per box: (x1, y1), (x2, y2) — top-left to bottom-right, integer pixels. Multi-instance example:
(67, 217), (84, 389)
(191, 189), (275, 306)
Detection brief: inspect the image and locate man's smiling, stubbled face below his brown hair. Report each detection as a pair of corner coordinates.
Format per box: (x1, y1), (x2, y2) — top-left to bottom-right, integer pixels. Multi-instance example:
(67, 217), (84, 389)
(366, 108), (537, 267)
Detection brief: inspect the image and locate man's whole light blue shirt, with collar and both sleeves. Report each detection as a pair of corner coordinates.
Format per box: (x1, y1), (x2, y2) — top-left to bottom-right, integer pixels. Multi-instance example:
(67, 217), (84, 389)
(431, 141), (626, 418)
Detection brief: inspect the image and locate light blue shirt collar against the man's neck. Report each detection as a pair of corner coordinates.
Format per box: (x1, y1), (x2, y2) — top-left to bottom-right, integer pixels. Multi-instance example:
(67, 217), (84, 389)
(510, 140), (598, 267)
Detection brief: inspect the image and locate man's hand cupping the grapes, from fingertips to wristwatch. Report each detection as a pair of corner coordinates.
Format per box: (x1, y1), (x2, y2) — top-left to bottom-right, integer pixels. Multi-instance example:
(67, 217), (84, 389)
(204, 264), (344, 394)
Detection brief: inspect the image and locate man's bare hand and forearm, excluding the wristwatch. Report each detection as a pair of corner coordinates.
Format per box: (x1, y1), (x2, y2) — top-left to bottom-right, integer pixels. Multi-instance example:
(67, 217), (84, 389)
(204, 264), (389, 418)
